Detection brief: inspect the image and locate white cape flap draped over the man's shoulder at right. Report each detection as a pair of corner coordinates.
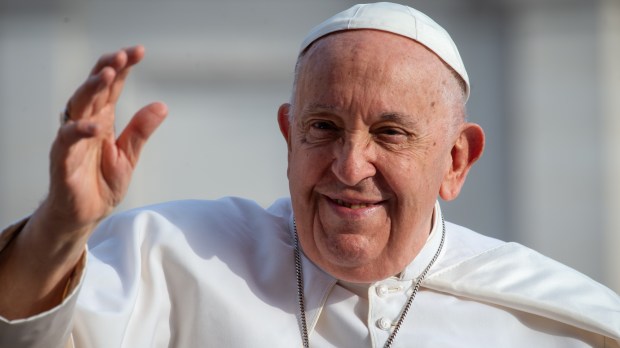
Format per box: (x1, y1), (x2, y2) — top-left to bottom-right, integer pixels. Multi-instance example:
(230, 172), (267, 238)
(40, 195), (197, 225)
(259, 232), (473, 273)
(425, 220), (620, 339)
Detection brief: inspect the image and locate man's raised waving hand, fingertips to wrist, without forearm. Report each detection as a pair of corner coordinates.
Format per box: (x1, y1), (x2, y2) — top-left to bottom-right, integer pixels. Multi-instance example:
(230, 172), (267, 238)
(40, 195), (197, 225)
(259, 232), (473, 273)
(45, 46), (166, 229)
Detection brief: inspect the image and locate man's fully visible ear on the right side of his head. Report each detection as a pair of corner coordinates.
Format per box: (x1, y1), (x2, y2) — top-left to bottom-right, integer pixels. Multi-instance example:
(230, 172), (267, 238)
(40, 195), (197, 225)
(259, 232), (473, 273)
(439, 123), (484, 201)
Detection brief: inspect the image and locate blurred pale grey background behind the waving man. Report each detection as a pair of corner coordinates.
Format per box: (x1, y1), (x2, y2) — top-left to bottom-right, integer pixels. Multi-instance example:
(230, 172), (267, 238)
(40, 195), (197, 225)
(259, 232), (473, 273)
(0, 0), (620, 292)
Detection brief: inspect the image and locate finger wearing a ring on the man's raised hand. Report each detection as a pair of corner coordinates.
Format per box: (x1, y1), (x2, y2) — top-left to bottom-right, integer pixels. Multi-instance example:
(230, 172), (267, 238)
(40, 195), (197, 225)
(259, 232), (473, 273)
(67, 67), (116, 120)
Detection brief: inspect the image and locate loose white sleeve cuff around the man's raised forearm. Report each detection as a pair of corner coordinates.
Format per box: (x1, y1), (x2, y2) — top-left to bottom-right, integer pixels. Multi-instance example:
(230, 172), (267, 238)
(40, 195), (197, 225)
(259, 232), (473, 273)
(0, 218), (86, 348)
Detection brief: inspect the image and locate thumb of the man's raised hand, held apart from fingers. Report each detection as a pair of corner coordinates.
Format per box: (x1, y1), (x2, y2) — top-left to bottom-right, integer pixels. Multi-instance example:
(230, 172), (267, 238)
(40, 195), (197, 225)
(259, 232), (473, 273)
(116, 102), (168, 167)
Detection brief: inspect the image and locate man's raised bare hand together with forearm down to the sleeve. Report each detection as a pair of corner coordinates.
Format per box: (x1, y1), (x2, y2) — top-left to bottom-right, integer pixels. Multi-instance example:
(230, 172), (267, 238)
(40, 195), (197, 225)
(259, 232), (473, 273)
(0, 46), (167, 318)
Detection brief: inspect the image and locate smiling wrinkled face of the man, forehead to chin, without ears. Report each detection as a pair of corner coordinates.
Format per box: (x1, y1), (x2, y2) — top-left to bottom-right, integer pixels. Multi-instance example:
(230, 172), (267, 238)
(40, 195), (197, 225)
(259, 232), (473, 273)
(281, 30), (457, 282)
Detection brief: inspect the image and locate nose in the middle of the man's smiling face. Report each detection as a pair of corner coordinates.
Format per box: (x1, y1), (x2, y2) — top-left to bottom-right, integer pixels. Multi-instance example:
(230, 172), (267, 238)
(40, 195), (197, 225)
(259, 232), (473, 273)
(332, 139), (377, 186)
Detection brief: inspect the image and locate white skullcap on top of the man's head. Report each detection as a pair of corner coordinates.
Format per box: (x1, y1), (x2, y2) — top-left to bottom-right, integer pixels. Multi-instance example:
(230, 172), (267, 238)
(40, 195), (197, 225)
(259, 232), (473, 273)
(299, 2), (470, 100)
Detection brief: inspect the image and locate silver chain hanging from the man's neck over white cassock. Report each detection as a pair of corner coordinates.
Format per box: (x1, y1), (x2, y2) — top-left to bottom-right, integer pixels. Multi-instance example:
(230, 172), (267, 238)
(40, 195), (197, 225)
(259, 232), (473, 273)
(293, 216), (446, 348)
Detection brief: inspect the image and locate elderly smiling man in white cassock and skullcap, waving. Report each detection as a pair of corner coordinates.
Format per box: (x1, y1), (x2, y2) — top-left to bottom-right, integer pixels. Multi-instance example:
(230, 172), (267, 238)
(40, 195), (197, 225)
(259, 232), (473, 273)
(0, 3), (620, 347)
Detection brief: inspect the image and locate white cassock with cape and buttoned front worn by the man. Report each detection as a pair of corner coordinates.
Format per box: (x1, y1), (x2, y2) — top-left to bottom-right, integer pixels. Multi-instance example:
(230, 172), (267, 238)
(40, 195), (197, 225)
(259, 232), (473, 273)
(0, 198), (620, 348)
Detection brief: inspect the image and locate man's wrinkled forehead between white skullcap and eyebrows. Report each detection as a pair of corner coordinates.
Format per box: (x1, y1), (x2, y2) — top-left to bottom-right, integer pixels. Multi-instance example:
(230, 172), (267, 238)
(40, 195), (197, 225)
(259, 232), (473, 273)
(295, 29), (452, 124)
